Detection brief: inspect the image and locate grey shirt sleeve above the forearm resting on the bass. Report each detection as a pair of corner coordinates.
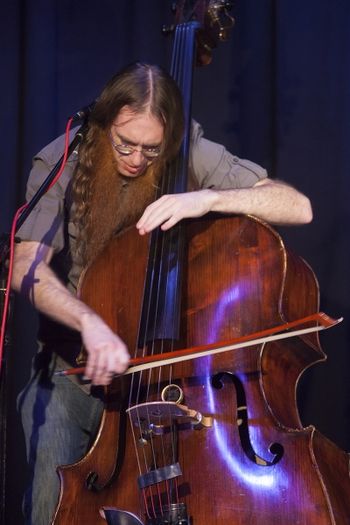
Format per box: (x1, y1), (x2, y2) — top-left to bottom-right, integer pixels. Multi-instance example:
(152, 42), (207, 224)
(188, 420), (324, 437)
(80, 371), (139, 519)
(189, 121), (267, 190)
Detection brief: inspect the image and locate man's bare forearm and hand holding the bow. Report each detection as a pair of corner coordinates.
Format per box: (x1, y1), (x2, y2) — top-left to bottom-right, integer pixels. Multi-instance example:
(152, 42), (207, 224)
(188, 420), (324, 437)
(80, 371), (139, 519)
(11, 241), (129, 385)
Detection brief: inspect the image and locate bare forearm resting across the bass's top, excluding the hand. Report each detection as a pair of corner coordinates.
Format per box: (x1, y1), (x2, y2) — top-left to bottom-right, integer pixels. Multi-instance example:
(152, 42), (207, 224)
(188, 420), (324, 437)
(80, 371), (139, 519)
(208, 181), (312, 225)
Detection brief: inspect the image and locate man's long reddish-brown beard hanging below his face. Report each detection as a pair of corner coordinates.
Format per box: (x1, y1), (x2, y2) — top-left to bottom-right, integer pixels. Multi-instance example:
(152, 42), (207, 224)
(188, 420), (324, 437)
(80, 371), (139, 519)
(83, 134), (161, 264)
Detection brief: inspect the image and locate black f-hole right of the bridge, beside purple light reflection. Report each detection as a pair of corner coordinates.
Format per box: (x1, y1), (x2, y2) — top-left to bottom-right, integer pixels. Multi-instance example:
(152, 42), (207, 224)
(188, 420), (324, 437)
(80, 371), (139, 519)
(212, 372), (284, 467)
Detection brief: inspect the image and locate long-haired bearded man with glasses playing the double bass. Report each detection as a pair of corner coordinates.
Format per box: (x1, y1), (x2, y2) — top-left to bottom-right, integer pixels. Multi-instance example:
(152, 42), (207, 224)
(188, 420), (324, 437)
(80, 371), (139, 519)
(13, 64), (312, 525)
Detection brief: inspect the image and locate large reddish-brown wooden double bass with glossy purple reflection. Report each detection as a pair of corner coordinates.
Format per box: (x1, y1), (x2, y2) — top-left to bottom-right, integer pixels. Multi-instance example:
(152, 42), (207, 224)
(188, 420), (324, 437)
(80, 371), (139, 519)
(53, 1), (350, 525)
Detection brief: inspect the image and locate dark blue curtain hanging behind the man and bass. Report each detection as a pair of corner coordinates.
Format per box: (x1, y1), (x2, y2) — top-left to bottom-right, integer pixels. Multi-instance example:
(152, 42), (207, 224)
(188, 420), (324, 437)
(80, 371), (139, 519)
(0, 0), (350, 523)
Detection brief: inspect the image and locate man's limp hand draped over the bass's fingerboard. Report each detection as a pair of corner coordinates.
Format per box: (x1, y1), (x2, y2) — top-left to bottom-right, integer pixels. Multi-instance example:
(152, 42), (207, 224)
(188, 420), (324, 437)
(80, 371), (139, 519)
(136, 190), (217, 235)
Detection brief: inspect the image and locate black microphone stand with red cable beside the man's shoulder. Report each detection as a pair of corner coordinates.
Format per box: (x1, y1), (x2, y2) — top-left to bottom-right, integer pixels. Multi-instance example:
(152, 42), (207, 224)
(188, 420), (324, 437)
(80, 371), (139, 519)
(0, 113), (88, 525)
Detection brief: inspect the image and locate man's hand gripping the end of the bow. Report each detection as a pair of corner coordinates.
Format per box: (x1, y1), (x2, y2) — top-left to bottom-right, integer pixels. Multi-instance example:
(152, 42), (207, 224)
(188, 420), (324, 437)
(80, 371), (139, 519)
(81, 313), (130, 385)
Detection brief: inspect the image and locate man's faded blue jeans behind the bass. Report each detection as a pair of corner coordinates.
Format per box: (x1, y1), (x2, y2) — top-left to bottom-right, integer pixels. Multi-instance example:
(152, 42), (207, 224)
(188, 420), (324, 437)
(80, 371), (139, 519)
(18, 352), (103, 525)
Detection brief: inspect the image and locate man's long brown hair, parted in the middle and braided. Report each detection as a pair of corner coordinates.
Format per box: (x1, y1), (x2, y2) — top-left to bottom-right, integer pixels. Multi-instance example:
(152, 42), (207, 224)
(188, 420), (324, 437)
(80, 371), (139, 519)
(72, 63), (183, 264)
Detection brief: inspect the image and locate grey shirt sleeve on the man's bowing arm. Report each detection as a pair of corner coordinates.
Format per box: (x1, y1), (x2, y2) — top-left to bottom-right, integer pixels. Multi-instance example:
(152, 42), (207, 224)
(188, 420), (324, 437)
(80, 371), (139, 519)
(16, 133), (73, 253)
